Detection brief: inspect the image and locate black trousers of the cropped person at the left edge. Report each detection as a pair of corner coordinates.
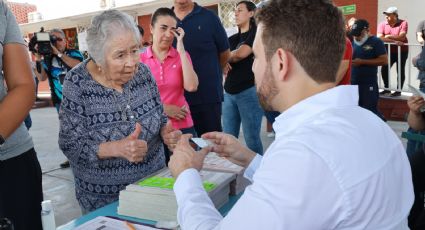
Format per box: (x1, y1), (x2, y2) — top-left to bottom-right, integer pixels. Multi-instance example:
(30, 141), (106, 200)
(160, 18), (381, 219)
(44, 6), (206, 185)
(0, 148), (43, 230)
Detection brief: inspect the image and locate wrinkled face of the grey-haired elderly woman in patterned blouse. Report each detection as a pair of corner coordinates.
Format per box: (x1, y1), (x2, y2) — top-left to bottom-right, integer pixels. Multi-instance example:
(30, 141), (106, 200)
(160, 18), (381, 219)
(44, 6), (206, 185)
(103, 32), (139, 85)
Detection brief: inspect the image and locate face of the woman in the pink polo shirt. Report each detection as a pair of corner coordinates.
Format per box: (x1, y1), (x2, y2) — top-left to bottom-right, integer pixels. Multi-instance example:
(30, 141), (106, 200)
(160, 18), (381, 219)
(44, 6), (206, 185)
(151, 16), (177, 49)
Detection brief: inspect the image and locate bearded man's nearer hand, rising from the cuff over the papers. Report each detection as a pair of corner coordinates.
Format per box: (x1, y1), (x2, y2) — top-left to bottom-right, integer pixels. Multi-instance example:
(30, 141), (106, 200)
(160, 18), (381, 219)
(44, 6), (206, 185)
(168, 134), (211, 178)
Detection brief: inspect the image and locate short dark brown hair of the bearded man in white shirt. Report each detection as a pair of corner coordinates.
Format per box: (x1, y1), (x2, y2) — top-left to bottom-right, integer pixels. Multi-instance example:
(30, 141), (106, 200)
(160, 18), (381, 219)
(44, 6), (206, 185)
(256, 0), (345, 83)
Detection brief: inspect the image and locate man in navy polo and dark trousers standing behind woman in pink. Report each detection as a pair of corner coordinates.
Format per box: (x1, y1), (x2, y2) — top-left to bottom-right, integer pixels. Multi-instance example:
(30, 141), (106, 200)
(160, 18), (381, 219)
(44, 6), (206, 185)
(173, 0), (230, 135)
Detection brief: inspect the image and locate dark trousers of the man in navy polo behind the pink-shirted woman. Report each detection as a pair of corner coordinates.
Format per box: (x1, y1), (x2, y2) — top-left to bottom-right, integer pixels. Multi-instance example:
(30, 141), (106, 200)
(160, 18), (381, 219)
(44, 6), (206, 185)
(190, 102), (223, 137)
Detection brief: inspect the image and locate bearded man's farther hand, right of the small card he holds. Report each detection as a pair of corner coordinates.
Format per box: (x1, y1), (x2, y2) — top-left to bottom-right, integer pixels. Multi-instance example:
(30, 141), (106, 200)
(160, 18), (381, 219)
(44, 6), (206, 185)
(202, 132), (257, 167)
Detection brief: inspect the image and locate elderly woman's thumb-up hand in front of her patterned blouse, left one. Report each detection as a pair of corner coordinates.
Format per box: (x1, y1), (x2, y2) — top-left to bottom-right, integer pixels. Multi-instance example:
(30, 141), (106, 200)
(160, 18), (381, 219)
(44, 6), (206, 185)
(118, 123), (148, 163)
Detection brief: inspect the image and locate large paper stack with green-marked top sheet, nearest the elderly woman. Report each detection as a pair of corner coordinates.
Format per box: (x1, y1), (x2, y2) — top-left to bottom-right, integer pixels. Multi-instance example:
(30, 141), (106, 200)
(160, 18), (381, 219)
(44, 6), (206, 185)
(118, 168), (235, 221)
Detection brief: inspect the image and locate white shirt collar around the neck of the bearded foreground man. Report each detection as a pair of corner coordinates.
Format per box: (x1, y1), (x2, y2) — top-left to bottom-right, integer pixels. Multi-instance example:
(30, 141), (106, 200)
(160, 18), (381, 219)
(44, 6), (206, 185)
(273, 85), (359, 137)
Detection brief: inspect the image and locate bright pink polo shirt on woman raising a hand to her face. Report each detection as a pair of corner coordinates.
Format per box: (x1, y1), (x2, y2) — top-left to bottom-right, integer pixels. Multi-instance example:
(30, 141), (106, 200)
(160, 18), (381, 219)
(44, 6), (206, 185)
(140, 46), (193, 129)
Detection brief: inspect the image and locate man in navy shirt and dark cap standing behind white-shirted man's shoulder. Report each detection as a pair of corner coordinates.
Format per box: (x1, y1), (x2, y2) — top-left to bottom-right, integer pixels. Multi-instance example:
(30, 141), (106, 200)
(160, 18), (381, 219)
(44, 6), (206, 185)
(350, 19), (387, 120)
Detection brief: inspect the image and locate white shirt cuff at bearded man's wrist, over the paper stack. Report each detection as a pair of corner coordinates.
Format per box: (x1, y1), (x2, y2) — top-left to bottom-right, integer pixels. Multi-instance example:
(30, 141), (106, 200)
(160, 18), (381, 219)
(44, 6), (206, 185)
(173, 168), (203, 202)
